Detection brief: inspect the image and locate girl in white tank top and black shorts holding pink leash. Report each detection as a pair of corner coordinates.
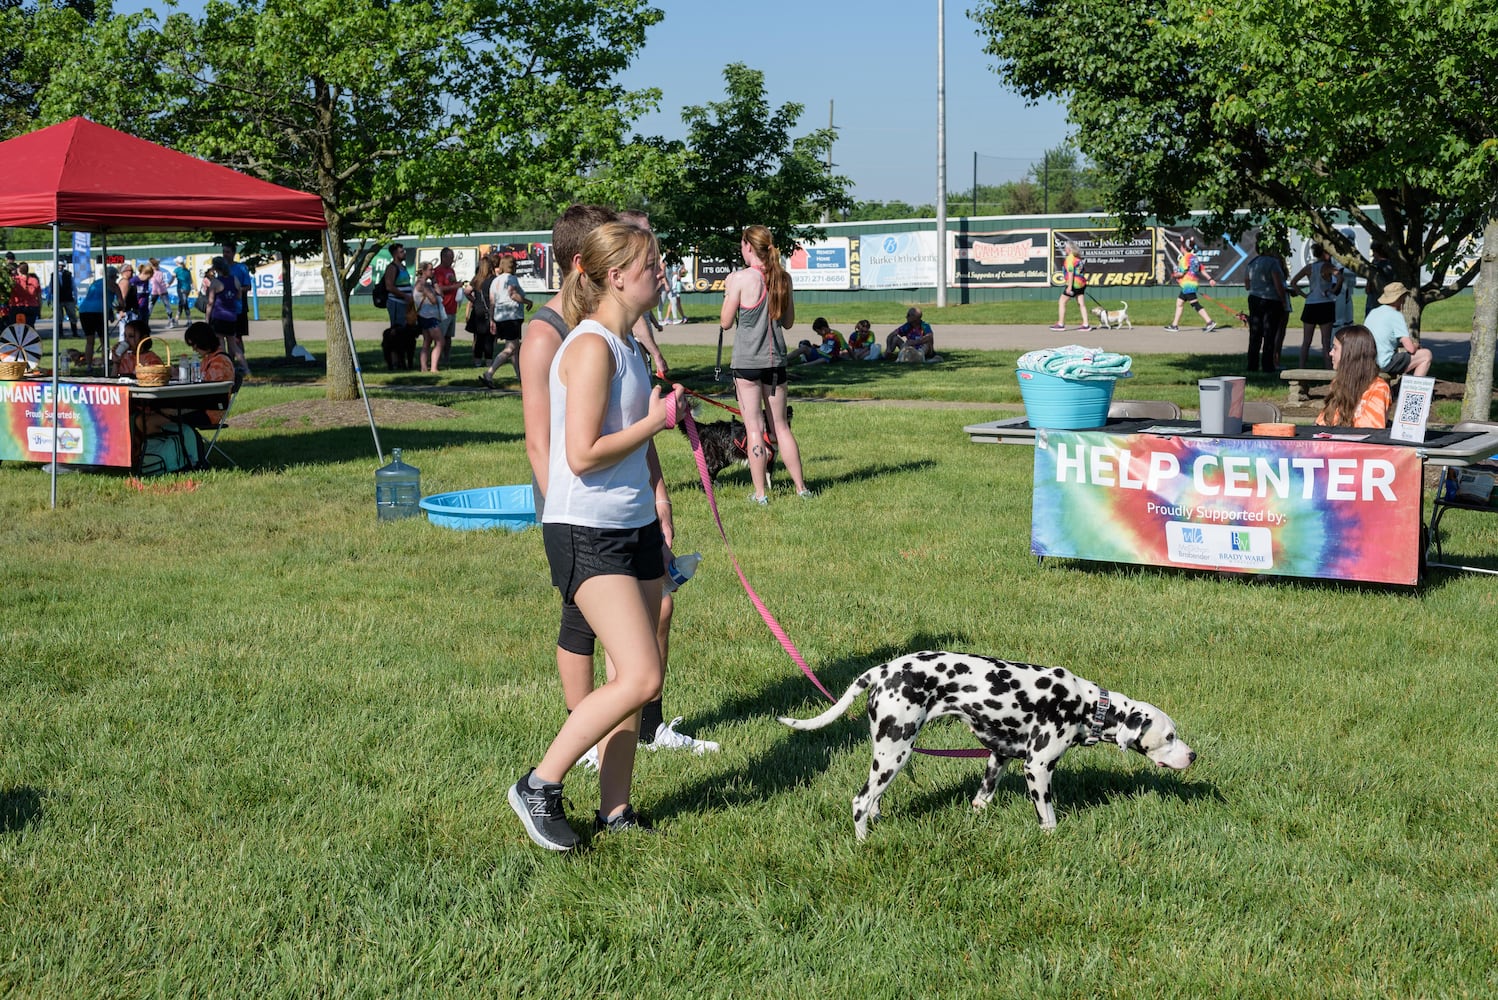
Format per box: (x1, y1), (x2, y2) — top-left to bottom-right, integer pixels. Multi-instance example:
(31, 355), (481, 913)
(509, 223), (682, 850)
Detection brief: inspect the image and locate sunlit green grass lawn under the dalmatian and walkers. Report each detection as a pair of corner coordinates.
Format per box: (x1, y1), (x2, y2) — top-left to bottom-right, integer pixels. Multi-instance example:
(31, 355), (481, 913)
(0, 346), (1498, 999)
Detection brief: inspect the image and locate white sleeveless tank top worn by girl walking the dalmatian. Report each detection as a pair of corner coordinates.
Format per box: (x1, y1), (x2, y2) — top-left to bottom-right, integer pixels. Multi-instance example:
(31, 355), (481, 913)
(541, 319), (655, 528)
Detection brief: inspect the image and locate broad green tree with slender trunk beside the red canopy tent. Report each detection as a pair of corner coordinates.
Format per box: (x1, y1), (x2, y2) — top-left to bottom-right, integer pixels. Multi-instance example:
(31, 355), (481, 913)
(21, 0), (661, 400)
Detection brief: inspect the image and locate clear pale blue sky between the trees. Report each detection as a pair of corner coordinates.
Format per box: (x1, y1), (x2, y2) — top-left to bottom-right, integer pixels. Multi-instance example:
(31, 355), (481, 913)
(115, 0), (1067, 205)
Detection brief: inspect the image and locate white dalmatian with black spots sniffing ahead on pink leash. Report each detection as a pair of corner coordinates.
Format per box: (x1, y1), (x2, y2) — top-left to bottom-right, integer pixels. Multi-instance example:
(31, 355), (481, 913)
(780, 650), (1197, 840)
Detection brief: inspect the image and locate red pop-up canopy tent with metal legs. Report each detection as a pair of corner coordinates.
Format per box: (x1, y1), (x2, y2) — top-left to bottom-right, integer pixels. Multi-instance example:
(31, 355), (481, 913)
(0, 118), (385, 506)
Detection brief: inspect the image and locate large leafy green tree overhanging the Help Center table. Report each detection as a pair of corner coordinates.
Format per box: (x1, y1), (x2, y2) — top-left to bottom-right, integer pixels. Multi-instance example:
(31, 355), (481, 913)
(975, 0), (1498, 415)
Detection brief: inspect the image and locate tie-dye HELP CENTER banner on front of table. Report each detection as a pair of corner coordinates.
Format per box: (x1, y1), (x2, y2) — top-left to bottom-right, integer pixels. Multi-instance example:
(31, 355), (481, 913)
(1031, 430), (1423, 585)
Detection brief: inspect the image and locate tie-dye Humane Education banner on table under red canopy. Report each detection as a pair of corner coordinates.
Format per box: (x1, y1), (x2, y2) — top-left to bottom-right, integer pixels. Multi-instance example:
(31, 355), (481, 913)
(0, 382), (130, 467)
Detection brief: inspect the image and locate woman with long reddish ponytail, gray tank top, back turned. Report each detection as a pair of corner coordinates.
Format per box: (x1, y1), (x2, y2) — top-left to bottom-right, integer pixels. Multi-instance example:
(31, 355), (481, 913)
(719, 226), (812, 504)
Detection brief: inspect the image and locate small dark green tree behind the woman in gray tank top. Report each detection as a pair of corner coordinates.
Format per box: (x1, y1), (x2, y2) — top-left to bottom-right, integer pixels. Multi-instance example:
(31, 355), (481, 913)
(650, 63), (852, 259)
